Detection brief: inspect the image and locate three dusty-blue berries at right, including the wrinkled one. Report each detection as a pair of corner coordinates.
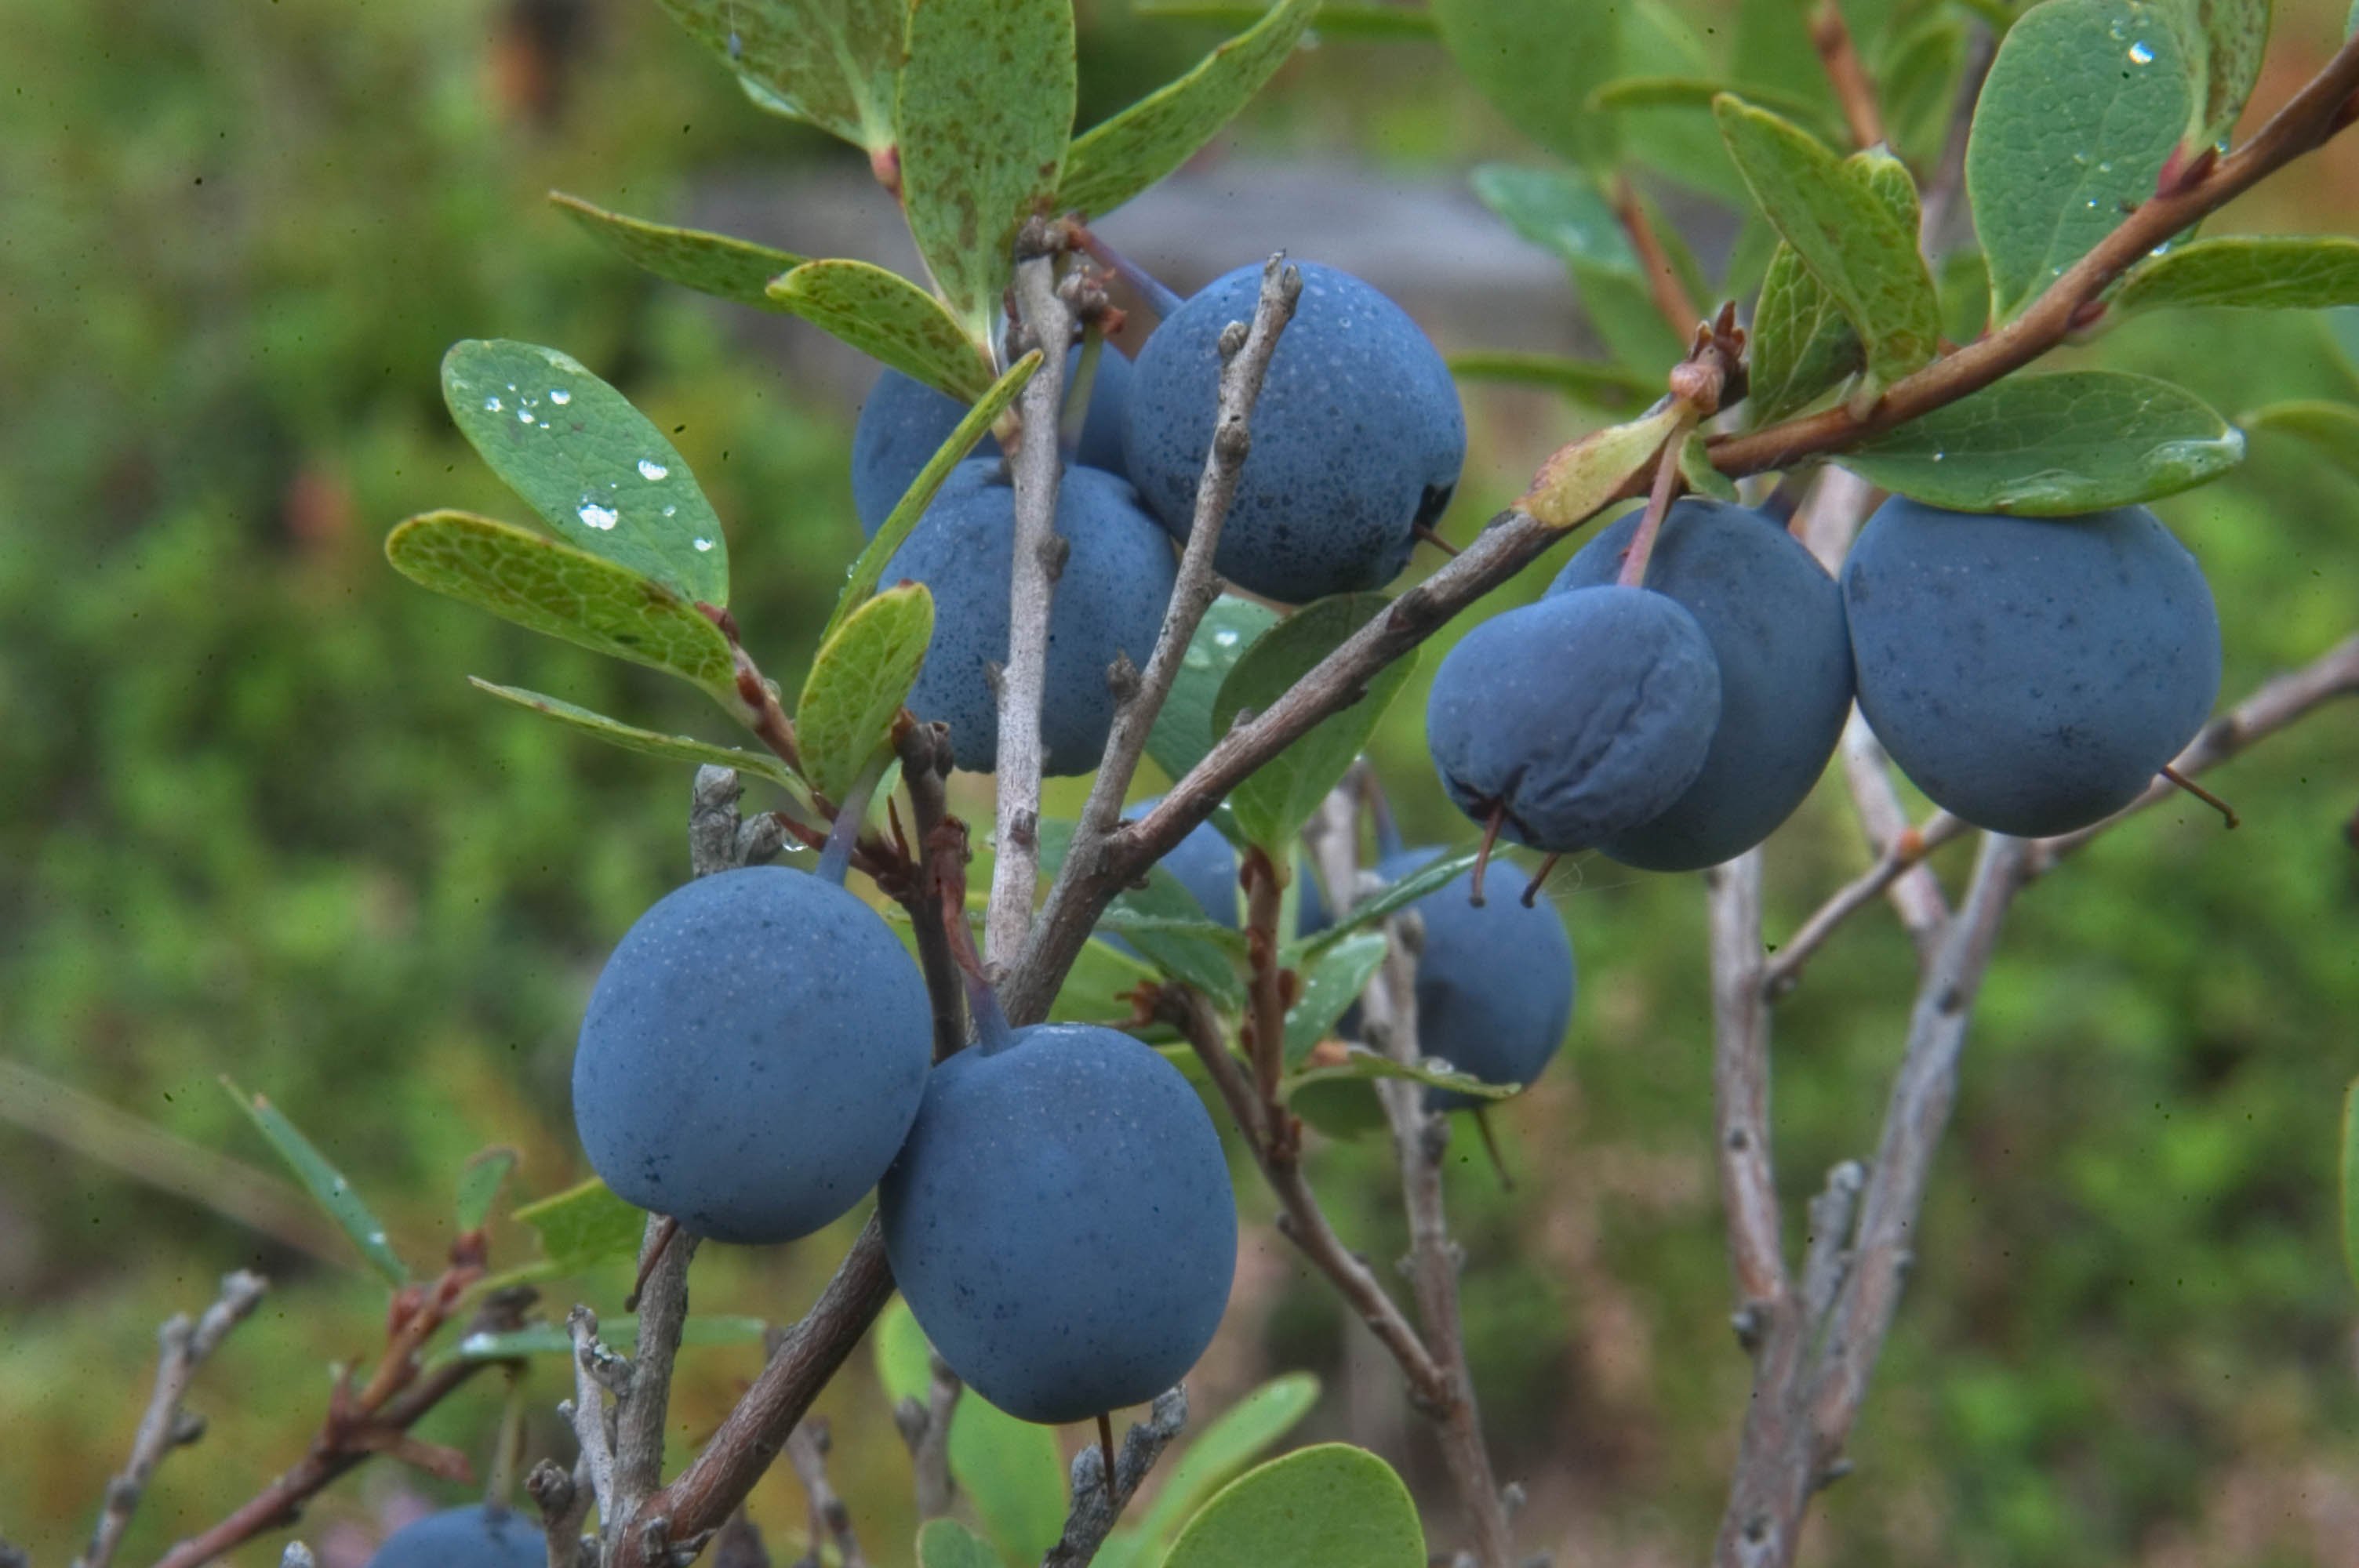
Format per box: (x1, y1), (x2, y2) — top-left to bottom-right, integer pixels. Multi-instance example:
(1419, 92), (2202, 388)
(1427, 498), (2220, 870)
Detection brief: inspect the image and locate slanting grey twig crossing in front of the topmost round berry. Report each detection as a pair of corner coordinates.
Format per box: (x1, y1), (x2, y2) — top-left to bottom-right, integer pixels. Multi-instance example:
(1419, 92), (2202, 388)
(1023, 252), (1302, 967)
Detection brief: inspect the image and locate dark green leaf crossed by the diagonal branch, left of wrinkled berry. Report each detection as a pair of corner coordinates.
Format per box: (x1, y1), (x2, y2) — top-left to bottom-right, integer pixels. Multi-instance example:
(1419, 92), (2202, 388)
(1212, 594), (1416, 858)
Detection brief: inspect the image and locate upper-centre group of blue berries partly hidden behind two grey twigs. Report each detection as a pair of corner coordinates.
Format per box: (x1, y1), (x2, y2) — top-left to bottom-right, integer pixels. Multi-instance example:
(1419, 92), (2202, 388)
(852, 262), (1465, 775)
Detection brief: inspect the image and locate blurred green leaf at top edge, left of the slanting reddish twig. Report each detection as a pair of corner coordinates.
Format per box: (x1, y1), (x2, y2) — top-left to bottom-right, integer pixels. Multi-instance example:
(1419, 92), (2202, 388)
(1427, 0), (1620, 168)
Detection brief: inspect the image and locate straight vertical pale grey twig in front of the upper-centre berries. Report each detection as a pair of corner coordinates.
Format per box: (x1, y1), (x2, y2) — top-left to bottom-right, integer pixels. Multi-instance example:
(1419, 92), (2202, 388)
(983, 241), (1074, 969)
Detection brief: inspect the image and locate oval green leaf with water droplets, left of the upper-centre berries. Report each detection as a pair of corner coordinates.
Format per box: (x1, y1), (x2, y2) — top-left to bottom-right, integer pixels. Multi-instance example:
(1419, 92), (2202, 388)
(444, 339), (729, 604)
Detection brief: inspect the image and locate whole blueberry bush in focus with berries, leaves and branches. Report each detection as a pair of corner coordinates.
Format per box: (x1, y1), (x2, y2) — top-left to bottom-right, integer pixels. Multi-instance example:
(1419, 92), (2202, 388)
(13, 0), (2359, 1568)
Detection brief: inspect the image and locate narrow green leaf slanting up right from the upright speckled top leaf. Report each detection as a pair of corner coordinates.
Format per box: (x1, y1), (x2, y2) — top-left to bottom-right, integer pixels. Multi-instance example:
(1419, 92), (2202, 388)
(1057, 0), (1318, 217)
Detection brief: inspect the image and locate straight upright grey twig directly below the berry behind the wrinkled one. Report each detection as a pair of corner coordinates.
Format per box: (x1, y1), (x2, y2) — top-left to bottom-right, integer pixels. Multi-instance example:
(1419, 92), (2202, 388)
(1703, 849), (1786, 1323)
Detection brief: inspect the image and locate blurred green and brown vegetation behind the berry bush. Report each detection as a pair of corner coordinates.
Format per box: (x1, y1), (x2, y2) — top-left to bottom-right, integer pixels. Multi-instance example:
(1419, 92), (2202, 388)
(0, 0), (2359, 1568)
